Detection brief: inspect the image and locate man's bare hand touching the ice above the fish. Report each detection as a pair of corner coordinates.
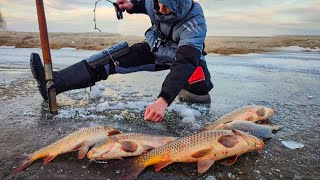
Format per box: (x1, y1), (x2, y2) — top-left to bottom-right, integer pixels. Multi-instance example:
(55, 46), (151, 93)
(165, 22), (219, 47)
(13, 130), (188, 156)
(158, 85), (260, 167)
(144, 97), (168, 122)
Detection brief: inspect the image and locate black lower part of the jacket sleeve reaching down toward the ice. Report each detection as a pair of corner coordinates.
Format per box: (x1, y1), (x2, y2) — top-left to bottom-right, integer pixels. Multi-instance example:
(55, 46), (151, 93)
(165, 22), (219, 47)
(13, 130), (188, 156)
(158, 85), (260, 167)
(159, 45), (201, 106)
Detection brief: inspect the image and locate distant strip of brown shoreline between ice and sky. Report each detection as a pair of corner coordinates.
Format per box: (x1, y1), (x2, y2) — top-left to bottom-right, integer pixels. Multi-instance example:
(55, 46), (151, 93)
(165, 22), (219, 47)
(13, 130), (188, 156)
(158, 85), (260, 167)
(0, 31), (320, 55)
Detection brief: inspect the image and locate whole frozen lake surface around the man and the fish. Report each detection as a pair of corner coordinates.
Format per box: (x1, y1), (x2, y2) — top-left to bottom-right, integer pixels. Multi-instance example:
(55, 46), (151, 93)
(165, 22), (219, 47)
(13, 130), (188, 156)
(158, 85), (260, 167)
(0, 47), (320, 179)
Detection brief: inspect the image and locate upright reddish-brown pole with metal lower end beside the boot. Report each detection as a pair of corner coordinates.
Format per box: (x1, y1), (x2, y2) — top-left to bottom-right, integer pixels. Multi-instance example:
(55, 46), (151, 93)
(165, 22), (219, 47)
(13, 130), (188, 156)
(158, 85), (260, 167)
(36, 0), (58, 114)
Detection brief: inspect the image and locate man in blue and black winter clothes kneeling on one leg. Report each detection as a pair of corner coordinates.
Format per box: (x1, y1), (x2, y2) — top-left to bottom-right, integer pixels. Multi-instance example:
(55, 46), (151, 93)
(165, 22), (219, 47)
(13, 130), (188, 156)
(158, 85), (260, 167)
(30, 0), (213, 122)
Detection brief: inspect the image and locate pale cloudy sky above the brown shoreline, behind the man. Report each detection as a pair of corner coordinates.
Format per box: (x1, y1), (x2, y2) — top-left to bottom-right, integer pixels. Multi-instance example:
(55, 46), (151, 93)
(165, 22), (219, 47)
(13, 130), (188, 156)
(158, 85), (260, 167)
(0, 0), (320, 36)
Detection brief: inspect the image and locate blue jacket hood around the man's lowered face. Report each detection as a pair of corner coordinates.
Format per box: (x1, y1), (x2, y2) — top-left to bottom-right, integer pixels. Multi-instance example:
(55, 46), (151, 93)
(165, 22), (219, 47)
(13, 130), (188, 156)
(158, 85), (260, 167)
(153, 0), (193, 22)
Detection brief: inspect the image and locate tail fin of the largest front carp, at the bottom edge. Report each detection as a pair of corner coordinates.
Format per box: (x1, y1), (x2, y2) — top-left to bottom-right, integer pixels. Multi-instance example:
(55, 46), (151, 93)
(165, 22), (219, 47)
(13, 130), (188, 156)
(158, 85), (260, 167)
(106, 158), (145, 180)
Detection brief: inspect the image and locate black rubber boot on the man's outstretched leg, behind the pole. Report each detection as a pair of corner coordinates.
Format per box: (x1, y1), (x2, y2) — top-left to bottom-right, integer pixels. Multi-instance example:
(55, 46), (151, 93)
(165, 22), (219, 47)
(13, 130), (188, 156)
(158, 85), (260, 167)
(30, 53), (98, 100)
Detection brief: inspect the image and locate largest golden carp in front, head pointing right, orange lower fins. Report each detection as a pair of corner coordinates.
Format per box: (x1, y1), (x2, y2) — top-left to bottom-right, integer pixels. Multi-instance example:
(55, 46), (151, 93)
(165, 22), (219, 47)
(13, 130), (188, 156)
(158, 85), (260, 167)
(107, 130), (264, 179)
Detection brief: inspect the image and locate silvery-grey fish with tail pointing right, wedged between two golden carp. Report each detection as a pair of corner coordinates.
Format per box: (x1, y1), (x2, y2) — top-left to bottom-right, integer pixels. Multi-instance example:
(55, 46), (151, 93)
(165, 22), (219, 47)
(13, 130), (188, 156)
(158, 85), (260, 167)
(214, 120), (284, 139)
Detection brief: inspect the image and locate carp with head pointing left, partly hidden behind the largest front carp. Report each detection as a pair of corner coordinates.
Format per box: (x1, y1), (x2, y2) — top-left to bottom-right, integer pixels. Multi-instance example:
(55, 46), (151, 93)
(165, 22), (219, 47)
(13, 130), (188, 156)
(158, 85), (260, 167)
(87, 133), (176, 160)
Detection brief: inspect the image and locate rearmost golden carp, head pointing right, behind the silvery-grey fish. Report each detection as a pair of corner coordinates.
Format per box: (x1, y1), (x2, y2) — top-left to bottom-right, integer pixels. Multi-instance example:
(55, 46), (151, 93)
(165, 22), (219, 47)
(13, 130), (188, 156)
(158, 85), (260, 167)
(202, 105), (274, 130)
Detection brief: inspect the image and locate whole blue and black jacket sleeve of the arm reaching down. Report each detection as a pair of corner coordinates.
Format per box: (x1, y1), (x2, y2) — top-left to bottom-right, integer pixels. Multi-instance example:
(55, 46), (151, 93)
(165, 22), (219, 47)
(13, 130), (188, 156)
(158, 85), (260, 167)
(159, 17), (207, 105)
